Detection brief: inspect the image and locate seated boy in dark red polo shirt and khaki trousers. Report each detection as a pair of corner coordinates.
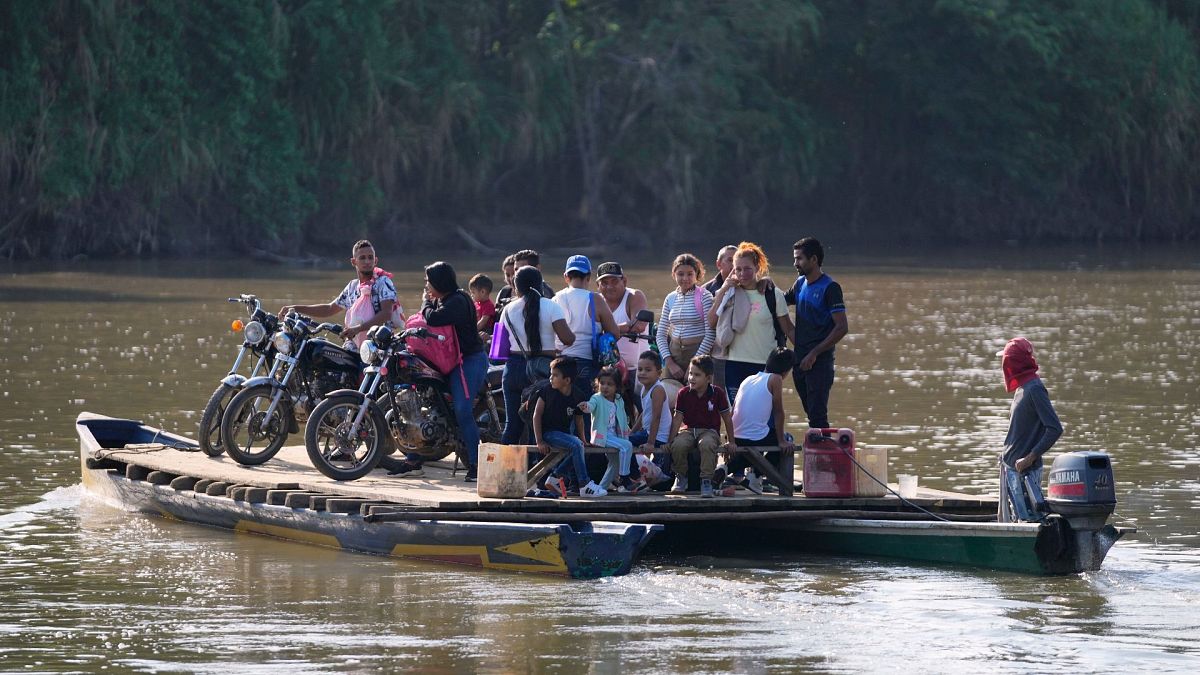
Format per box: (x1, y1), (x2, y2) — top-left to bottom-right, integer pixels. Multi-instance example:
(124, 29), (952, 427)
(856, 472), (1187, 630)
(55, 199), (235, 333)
(667, 354), (736, 497)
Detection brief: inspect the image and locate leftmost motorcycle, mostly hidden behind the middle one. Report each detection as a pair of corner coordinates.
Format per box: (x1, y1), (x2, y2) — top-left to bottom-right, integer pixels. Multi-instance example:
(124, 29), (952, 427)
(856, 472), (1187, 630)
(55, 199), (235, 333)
(199, 294), (280, 456)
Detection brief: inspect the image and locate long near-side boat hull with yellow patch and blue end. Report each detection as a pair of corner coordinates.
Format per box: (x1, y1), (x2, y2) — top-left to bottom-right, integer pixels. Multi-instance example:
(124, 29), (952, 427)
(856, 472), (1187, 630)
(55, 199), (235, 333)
(77, 416), (662, 579)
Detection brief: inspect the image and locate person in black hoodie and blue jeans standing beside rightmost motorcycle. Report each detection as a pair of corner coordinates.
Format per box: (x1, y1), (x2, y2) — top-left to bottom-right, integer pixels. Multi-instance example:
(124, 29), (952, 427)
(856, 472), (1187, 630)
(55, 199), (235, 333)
(389, 261), (487, 483)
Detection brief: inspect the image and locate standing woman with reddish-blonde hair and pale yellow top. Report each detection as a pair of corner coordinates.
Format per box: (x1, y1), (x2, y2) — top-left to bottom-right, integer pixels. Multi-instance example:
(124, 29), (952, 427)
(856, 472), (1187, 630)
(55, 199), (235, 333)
(708, 241), (794, 401)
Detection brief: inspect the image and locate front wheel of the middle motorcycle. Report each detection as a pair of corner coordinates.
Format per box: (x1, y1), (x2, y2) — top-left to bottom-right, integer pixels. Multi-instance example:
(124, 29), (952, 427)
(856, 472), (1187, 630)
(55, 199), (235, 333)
(221, 384), (292, 466)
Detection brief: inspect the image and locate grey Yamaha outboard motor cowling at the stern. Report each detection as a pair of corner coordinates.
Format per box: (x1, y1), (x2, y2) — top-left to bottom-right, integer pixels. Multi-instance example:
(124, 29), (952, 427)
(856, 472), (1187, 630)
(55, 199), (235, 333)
(1046, 452), (1117, 530)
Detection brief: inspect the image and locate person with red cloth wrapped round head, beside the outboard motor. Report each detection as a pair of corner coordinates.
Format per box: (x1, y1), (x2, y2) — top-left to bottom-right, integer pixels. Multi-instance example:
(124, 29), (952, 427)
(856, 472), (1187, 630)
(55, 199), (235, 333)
(996, 338), (1062, 522)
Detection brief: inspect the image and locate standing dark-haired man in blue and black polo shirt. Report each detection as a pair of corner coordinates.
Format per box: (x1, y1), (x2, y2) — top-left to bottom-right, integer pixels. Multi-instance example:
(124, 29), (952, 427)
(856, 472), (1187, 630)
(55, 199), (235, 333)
(786, 237), (847, 429)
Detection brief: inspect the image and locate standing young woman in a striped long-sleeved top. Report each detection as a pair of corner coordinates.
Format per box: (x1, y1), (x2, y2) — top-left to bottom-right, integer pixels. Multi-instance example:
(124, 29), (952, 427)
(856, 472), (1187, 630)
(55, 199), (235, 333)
(658, 253), (714, 382)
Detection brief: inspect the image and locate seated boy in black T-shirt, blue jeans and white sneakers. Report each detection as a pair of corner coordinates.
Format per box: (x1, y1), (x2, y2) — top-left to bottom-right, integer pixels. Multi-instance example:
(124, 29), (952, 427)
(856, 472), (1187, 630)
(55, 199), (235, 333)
(532, 357), (608, 497)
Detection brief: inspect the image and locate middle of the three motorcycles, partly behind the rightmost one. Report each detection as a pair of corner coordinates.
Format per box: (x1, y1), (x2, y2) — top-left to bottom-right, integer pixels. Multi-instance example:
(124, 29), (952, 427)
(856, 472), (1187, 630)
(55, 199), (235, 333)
(221, 312), (362, 465)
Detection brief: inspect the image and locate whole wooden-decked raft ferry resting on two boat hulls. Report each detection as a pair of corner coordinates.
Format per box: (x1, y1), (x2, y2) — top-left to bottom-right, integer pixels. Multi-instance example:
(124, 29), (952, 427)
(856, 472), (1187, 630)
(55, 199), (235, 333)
(76, 413), (1130, 579)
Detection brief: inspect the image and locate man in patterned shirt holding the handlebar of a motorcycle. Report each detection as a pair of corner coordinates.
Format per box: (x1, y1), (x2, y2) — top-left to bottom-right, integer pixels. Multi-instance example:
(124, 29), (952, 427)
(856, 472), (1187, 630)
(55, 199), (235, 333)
(280, 239), (404, 346)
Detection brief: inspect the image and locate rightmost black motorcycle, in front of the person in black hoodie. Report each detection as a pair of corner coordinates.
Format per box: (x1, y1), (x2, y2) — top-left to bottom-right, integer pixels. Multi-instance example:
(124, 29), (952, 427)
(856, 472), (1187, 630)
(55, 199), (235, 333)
(305, 327), (503, 480)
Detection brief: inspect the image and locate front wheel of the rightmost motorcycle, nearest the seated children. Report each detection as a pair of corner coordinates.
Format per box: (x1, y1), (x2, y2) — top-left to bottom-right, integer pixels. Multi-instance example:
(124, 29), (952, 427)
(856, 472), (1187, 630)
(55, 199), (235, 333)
(304, 395), (388, 480)
